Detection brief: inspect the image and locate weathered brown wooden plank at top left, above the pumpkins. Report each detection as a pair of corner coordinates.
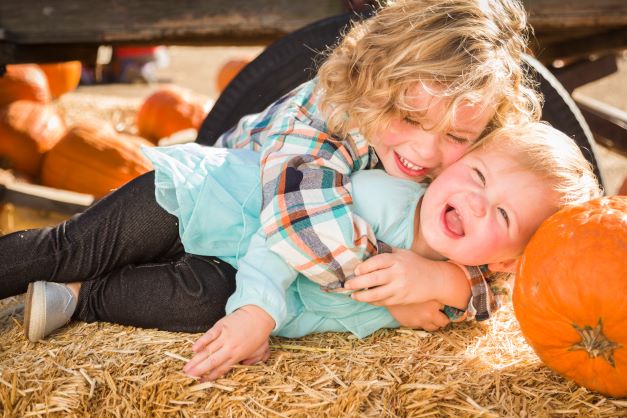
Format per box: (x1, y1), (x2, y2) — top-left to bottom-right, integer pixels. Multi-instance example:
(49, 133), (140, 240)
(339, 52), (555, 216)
(0, 0), (345, 45)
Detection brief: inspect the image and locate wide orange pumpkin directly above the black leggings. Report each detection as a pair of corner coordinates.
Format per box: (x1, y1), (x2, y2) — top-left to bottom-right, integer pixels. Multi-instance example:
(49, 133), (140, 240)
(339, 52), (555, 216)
(41, 122), (152, 197)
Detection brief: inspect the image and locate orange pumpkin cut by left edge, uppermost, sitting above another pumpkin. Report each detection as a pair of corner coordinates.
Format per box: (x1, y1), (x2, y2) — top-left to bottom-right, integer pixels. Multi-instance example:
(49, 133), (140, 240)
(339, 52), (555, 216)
(0, 64), (50, 106)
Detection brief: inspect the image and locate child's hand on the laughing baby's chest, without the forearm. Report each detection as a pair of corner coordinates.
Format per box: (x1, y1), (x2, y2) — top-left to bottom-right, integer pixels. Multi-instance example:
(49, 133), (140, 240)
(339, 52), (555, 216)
(344, 249), (446, 306)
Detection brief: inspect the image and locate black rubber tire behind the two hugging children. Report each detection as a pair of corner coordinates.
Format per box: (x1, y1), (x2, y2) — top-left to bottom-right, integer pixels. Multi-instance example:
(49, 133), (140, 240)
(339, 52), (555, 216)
(196, 13), (603, 184)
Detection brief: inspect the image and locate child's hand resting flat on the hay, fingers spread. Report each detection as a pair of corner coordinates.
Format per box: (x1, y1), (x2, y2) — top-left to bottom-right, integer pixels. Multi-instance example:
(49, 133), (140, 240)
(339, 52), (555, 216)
(183, 305), (274, 380)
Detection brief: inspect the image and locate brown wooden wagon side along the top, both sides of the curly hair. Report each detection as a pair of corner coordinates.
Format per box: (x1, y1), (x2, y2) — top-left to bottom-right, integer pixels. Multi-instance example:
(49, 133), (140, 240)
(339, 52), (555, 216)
(0, 0), (627, 65)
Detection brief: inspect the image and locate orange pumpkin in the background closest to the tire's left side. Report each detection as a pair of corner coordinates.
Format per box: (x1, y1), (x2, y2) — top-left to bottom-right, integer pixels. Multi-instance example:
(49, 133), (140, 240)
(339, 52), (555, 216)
(136, 85), (209, 143)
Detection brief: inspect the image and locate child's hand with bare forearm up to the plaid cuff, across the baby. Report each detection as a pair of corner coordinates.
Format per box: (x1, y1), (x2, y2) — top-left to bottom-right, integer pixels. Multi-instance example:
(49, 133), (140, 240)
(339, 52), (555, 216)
(344, 249), (471, 309)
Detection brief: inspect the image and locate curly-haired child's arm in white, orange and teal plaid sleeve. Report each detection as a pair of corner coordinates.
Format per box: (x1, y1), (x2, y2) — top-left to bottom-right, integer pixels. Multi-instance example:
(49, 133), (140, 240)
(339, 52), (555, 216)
(261, 120), (379, 286)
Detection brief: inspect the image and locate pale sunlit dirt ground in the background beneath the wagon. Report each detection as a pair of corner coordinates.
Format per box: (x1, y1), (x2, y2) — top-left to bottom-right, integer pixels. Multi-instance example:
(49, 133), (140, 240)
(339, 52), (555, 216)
(77, 46), (627, 194)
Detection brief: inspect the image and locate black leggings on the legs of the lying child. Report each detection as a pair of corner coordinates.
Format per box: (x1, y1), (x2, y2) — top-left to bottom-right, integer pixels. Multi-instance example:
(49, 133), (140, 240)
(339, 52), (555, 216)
(0, 172), (236, 332)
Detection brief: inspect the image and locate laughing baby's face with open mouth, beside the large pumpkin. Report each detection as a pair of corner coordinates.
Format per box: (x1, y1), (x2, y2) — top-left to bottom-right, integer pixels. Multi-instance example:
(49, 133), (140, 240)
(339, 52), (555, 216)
(418, 147), (557, 265)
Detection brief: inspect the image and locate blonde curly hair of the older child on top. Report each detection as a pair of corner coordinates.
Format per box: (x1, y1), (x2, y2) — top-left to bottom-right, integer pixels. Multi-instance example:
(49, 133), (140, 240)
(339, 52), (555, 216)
(318, 0), (541, 138)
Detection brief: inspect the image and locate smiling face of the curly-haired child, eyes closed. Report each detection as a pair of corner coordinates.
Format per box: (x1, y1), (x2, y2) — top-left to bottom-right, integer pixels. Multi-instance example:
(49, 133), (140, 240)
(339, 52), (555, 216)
(372, 86), (494, 181)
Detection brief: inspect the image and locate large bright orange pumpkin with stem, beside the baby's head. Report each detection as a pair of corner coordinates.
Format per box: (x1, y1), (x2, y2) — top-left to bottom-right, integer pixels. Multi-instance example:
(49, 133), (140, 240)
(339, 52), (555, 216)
(513, 196), (627, 397)
